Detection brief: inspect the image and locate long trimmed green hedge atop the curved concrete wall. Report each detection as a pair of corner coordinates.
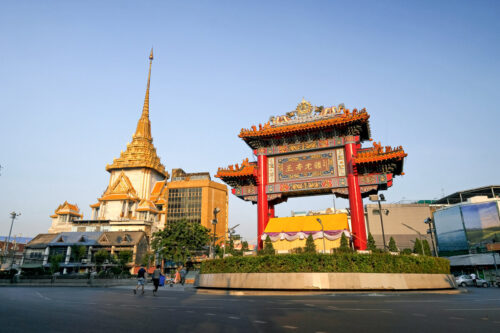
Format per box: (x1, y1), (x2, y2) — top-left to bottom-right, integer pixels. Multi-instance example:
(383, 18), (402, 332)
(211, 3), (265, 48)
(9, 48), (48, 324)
(200, 252), (450, 274)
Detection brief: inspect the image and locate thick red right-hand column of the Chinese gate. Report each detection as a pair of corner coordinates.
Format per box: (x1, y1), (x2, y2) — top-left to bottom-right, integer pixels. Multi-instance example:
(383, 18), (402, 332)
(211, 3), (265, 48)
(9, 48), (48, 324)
(345, 140), (366, 250)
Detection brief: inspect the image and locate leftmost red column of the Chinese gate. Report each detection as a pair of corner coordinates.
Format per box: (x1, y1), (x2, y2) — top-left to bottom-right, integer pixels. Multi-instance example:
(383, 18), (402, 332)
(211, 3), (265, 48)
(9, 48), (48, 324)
(257, 155), (269, 250)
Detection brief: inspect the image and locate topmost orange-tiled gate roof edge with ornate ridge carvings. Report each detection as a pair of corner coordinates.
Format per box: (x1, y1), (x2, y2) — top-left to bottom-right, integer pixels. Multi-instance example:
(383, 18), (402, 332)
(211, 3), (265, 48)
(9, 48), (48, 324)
(238, 99), (370, 139)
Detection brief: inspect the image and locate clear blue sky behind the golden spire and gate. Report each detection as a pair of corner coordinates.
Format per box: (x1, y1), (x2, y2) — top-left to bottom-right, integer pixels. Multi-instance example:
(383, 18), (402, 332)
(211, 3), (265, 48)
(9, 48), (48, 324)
(0, 1), (500, 241)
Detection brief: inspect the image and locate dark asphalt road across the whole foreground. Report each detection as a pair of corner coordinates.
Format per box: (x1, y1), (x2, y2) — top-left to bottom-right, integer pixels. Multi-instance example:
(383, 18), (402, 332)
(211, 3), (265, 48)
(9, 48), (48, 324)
(0, 286), (500, 333)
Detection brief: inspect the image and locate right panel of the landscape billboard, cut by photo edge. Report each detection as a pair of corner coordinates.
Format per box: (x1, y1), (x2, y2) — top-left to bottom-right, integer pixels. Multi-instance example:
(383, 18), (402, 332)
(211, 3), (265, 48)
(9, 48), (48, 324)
(461, 201), (500, 247)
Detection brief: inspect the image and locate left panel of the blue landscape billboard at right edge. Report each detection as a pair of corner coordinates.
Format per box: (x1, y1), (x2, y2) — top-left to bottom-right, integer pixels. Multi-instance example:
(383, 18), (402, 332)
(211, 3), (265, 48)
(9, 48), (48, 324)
(434, 206), (469, 255)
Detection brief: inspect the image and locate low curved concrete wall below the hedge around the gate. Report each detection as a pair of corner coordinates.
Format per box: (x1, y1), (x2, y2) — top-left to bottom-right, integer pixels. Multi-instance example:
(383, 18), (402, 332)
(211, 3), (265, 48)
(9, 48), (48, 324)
(195, 273), (457, 290)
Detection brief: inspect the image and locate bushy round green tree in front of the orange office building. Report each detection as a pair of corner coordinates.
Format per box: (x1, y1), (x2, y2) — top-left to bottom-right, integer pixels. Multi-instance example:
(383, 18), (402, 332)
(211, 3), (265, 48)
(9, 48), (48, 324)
(151, 220), (210, 263)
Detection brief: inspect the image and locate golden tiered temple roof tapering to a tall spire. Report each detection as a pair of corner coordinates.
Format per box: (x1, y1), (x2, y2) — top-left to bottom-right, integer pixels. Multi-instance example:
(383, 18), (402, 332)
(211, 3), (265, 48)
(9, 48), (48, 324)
(106, 49), (169, 179)
